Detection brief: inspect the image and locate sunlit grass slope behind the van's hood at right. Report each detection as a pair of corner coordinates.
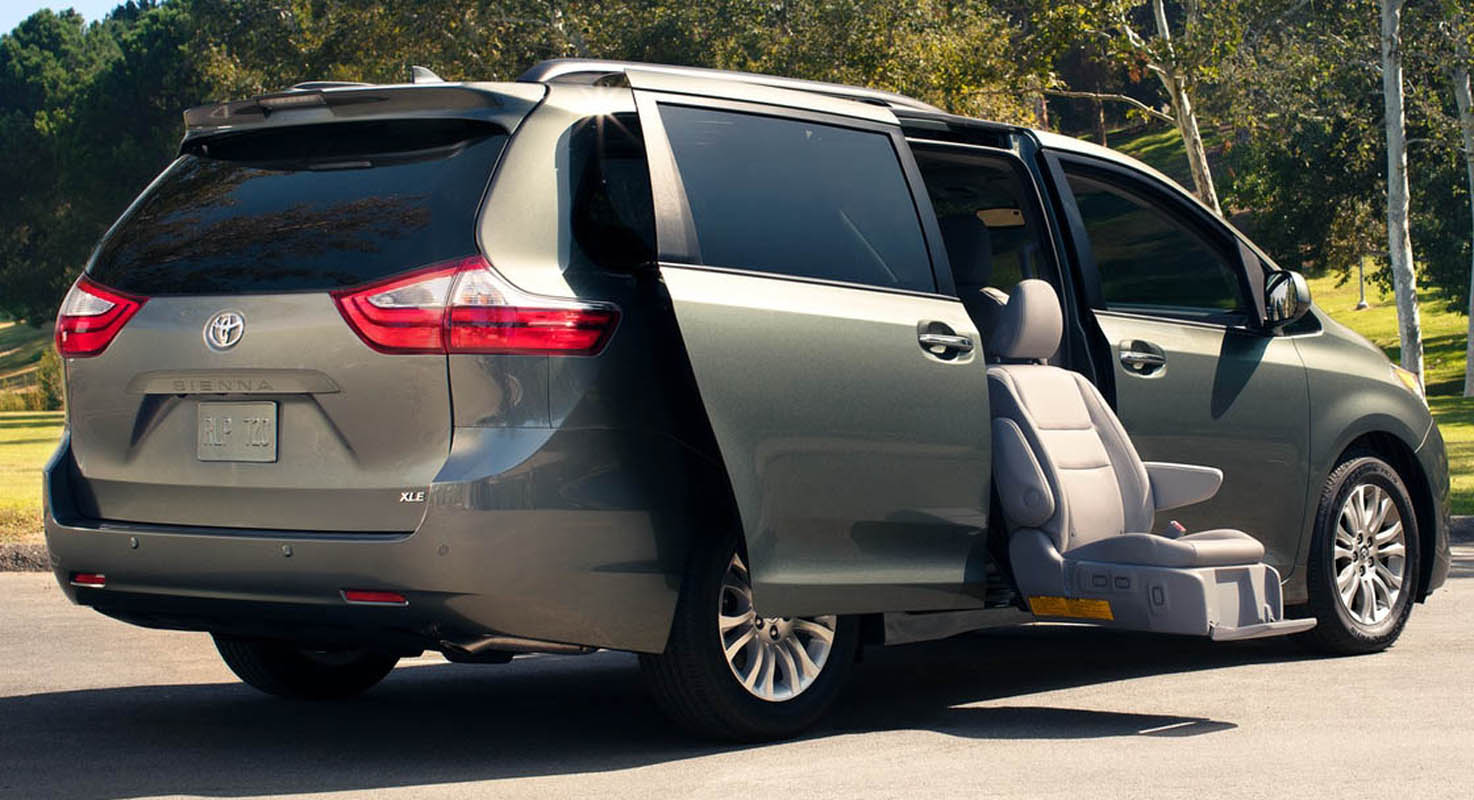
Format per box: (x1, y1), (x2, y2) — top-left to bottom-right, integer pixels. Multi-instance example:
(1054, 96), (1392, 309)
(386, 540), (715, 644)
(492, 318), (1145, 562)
(1310, 277), (1474, 514)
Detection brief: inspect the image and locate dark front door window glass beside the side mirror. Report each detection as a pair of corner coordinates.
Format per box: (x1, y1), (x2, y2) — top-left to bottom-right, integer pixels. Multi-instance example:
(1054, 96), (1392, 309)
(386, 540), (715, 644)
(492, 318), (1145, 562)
(1066, 168), (1244, 318)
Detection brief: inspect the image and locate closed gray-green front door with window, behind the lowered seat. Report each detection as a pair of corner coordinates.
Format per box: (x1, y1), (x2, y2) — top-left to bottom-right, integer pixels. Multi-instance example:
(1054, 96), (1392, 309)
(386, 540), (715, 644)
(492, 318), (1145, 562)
(1061, 158), (1309, 578)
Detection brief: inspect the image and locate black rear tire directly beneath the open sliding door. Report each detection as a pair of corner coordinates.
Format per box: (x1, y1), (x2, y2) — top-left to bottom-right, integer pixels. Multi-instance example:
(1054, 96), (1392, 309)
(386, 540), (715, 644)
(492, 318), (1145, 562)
(640, 536), (859, 741)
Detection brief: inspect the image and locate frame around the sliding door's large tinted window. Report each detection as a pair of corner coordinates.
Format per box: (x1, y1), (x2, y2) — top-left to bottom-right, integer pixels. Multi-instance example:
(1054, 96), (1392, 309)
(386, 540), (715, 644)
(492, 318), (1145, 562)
(634, 90), (955, 296)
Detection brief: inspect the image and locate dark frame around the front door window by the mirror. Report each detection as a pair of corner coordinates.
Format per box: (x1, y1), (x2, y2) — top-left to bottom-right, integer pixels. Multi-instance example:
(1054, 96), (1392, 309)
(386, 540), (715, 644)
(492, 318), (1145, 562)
(1048, 150), (1262, 330)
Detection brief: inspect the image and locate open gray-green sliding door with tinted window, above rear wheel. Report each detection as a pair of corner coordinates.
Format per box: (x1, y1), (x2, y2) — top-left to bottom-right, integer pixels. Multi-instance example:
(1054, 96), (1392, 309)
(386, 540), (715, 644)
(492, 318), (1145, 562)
(631, 74), (989, 616)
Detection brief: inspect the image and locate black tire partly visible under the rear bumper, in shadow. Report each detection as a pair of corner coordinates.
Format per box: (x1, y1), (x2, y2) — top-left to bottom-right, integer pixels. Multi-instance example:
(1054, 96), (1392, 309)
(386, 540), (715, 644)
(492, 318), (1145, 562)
(215, 635), (399, 700)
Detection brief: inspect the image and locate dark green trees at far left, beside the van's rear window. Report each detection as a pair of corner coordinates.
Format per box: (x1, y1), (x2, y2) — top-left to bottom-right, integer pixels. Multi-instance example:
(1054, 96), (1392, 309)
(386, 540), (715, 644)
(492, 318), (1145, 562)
(0, 3), (200, 323)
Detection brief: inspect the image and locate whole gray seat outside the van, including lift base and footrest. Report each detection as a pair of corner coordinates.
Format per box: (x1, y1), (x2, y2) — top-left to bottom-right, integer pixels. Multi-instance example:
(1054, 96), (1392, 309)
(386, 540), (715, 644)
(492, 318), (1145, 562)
(986, 280), (1315, 639)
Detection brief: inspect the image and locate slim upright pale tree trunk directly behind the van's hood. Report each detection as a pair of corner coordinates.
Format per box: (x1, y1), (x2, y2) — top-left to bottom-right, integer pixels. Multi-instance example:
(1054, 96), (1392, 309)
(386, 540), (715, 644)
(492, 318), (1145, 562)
(1381, 0), (1424, 383)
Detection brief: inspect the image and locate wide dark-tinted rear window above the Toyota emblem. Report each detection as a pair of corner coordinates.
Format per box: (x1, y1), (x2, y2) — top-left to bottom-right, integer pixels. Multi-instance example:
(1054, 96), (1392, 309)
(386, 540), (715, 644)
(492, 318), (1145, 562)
(88, 119), (507, 295)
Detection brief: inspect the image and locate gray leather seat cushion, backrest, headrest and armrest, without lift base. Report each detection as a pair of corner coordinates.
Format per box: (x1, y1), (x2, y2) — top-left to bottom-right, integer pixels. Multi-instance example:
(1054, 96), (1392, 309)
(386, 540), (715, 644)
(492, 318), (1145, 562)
(988, 280), (1265, 567)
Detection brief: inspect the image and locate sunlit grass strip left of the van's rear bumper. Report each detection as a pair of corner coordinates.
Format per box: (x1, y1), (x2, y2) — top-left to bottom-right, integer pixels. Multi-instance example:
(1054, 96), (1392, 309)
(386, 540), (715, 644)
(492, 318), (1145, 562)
(0, 411), (62, 542)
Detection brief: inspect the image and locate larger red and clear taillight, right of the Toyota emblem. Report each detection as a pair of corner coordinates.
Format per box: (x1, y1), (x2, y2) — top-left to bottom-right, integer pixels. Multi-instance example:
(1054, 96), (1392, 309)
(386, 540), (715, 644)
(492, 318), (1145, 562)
(333, 255), (619, 355)
